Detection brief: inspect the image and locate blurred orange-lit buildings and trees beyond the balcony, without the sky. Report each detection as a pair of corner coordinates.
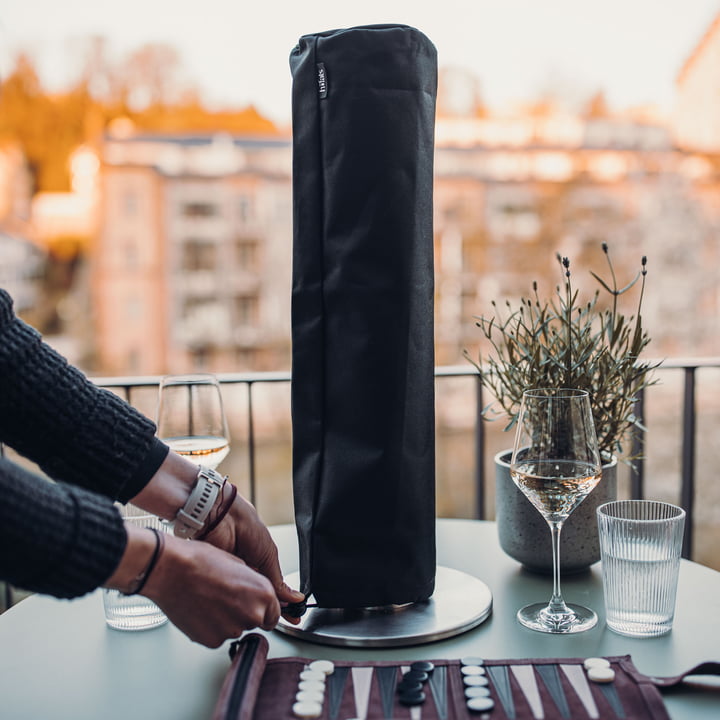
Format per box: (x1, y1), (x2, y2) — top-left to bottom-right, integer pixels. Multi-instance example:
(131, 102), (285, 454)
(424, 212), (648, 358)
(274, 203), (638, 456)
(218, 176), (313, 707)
(0, 4), (720, 566)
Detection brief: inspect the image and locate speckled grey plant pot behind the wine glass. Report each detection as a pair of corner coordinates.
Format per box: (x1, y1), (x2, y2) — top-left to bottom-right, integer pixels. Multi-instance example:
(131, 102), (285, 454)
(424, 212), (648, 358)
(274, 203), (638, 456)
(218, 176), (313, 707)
(495, 450), (617, 575)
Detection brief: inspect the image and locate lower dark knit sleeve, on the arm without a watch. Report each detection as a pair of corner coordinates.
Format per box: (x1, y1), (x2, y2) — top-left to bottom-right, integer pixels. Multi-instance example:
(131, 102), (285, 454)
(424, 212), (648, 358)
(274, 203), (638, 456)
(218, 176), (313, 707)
(0, 458), (127, 598)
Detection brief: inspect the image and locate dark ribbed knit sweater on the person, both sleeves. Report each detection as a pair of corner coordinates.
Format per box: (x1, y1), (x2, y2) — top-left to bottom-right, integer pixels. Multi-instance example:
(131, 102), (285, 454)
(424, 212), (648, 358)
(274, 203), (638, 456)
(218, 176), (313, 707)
(0, 289), (168, 598)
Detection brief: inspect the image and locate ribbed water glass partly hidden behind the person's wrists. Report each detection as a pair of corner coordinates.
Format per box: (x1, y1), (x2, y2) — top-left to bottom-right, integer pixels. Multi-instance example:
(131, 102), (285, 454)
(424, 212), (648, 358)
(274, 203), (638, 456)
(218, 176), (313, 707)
(103, 504), (167, 630)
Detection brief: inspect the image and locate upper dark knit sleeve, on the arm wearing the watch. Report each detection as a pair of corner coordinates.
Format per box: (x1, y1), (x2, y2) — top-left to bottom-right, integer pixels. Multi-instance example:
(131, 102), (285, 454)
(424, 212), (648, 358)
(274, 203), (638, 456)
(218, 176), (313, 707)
(0, 289), (168, 502)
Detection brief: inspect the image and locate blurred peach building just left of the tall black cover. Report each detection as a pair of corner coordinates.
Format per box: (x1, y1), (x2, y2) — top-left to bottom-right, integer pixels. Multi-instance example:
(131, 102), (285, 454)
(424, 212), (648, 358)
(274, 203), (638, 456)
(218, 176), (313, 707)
(91, 128), (292, 374)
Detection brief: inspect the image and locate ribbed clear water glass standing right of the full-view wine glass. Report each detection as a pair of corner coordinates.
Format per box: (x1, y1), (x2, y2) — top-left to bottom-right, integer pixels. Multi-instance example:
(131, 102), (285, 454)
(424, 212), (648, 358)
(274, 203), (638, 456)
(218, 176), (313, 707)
(597, 500), (685, 637)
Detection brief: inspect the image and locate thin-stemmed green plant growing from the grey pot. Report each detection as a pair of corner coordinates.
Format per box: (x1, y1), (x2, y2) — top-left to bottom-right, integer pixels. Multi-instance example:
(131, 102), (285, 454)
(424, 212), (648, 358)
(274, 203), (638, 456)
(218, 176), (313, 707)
(464, 243), (660, 461)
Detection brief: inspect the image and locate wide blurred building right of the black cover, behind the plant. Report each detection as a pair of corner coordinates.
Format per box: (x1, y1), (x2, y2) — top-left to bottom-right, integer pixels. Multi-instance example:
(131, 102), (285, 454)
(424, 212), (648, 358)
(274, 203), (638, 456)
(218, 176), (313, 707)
(435, 105), (720, 365)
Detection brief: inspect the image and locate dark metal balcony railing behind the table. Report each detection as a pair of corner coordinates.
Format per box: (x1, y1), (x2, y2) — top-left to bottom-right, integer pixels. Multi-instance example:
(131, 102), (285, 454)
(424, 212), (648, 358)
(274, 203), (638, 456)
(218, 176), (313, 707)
(90, 358), (720, 558)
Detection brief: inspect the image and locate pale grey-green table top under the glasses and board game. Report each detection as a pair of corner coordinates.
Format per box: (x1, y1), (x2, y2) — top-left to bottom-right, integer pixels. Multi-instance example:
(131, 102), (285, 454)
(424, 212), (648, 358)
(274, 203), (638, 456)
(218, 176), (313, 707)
(0, 520), (720, 720)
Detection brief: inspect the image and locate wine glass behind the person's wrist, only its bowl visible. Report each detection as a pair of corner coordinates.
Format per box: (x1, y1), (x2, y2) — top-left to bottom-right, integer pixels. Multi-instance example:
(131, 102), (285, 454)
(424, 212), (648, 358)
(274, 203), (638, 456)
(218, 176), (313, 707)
(157, 373), (230, 470)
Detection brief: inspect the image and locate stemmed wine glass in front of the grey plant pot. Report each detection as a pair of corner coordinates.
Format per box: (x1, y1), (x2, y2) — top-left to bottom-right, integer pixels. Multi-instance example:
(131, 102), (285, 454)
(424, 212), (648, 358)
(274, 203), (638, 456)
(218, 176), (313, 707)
(510, 388), (602, 633)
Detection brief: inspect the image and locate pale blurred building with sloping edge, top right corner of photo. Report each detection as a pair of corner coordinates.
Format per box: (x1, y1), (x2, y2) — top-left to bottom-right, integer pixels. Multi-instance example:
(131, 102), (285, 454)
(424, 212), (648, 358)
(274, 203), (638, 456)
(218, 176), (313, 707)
(674, 9), (720, 152)
